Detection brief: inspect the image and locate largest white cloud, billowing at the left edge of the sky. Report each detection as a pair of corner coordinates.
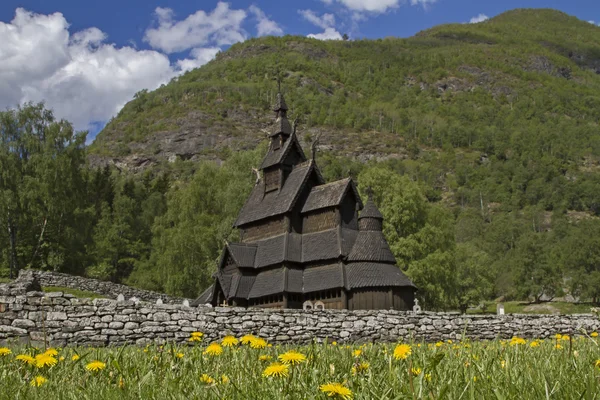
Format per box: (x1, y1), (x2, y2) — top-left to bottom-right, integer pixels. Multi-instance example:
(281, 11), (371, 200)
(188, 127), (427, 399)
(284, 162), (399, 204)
(0, 8), (178, 129)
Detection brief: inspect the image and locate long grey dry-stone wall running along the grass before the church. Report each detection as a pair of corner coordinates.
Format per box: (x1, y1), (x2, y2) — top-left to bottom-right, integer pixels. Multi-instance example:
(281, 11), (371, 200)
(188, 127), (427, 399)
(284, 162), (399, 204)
(0, 280), (600, 346)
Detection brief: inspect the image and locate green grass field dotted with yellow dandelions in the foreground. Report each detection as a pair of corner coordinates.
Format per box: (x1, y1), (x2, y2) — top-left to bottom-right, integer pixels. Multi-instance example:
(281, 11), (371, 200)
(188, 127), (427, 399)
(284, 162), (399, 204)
(0, 333), (600, 400)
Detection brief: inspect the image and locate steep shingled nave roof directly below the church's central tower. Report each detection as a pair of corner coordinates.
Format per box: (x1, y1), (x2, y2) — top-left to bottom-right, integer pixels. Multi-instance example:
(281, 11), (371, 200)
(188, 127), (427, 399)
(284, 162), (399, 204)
(234, 160), (323, 227)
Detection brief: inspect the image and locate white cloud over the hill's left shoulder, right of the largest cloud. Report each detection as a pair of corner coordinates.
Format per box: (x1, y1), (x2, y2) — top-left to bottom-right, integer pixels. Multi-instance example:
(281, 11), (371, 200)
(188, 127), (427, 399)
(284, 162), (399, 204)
(144, 2), (247, 53)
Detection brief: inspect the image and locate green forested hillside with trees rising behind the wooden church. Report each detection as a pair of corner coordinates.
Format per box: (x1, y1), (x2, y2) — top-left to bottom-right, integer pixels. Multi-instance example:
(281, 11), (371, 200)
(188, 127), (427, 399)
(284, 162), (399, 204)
(0, 10), (600, 309)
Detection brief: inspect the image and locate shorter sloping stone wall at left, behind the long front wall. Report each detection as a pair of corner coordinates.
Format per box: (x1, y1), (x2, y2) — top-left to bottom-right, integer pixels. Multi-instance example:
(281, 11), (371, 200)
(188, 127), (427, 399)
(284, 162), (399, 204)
(22, 270), (184, 304)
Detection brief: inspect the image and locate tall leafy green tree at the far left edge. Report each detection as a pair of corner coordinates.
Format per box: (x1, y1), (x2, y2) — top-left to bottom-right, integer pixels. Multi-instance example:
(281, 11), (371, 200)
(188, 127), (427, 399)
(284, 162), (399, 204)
(0, 103), (86, 277)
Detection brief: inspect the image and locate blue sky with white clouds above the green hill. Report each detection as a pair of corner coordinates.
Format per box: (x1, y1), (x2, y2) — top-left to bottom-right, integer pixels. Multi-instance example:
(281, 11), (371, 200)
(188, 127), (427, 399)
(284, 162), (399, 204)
(0, 0), (600, 142)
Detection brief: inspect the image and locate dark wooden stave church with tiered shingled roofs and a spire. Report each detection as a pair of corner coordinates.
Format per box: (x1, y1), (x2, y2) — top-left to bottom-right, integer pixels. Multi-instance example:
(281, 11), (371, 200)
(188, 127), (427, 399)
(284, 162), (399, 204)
(194, 94), (416, 310)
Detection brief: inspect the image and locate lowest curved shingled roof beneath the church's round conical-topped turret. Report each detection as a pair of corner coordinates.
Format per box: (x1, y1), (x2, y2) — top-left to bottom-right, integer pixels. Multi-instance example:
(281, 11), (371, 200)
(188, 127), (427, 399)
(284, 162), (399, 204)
(345, 262), (415, 289)
